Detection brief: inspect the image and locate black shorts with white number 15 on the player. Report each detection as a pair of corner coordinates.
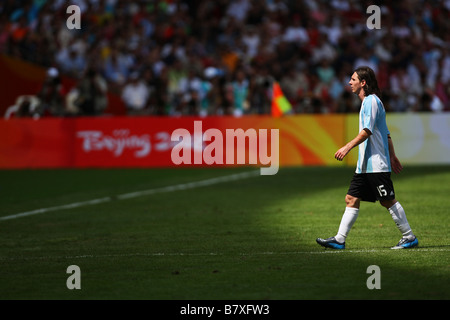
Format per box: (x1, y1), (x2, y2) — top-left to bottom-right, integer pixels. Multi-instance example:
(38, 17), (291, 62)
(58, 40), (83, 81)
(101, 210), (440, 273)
(347, 172), (395, 202)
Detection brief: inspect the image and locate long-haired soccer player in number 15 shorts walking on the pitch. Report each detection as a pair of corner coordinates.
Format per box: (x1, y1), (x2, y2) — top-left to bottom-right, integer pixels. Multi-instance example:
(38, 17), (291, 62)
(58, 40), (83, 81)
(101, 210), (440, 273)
(316, 67), (419, 249)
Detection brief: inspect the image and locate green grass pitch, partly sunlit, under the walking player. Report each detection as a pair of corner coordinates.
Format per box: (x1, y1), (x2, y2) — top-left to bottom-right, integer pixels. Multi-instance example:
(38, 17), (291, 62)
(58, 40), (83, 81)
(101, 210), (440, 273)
(0, 166), (450, 300)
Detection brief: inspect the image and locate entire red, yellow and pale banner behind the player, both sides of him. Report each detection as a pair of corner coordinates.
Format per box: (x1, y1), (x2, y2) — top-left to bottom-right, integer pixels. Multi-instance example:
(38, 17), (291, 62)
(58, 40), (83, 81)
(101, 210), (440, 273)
(0, 114), (450, 169)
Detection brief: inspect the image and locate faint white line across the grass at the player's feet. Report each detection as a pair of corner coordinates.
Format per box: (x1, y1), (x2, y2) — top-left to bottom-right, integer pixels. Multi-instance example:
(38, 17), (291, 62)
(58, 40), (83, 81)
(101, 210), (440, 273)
(0, 248), (450, 261)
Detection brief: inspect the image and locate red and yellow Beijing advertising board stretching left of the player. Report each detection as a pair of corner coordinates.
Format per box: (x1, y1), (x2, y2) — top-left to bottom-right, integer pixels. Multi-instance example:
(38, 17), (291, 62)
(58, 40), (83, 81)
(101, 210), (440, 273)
(0, 116), (344, 169)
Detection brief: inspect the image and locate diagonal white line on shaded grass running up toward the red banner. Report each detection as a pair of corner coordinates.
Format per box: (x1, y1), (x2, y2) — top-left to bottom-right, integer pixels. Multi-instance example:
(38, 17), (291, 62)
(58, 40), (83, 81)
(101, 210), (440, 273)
(0, 170), (260, 221)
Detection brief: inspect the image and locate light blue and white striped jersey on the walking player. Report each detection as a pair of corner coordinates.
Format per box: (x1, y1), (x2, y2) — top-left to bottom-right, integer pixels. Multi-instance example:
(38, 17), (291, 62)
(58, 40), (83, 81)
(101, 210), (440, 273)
(356, 94), (391, 173)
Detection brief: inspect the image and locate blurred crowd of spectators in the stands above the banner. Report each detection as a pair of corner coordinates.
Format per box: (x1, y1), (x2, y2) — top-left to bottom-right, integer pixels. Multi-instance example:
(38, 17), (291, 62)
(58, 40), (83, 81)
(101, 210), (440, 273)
(0, 0), (450, 116)
